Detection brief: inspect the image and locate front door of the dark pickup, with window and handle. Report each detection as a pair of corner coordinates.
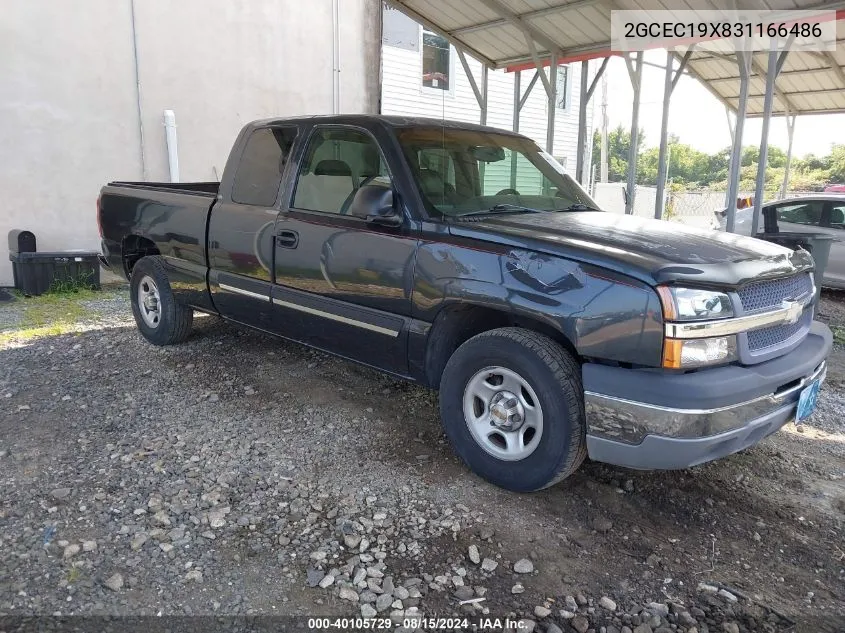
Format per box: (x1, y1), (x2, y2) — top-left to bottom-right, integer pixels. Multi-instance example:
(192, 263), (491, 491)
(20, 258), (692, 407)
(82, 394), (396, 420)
(273, 125), (417, 375)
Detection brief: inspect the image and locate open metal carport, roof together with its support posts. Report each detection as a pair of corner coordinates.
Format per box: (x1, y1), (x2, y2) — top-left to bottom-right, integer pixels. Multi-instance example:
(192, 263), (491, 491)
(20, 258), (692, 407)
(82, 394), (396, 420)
(387, 0), (845, 230)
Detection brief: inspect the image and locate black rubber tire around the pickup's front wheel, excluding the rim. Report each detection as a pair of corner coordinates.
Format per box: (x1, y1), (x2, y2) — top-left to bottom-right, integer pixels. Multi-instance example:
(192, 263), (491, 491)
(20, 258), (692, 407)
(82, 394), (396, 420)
(440, 327), (587, 492)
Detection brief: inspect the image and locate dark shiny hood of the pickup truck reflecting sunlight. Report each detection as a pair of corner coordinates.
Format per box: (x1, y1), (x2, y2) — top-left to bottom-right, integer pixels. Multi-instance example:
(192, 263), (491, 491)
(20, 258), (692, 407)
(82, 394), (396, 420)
(450, 211), (813, 288)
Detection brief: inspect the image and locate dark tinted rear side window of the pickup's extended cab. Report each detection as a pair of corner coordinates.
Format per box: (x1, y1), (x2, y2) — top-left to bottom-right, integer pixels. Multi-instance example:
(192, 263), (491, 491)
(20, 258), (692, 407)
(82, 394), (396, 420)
(232, 127), (296, 207)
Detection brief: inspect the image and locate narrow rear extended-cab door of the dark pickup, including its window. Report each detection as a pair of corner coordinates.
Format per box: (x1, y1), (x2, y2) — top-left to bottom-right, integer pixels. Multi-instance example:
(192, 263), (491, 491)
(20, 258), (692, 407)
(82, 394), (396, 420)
(208, 126), (298, 330)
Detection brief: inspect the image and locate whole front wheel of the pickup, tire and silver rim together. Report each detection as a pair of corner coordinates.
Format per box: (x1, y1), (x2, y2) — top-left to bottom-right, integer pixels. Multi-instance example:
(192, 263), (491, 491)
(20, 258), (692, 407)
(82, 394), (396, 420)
(440, 328), (586, 492)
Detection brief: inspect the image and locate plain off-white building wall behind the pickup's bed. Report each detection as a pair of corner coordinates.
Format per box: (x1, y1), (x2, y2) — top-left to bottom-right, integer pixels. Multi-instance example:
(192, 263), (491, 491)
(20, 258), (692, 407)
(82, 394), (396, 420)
(0, 0), (381, 285)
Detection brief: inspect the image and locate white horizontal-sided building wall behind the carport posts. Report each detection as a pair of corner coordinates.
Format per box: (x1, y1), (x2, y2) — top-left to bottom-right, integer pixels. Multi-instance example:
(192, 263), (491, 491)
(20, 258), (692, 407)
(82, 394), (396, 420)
(381, 8), (592, 174)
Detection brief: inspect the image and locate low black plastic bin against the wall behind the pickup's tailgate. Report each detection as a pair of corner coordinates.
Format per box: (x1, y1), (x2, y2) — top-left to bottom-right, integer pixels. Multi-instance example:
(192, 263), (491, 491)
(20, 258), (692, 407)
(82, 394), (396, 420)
(9, 251), (100, 296)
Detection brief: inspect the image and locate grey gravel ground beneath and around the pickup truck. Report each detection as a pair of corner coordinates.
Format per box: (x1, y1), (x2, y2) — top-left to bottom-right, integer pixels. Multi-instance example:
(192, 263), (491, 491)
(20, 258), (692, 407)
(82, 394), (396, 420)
(0, 289), (845, 633)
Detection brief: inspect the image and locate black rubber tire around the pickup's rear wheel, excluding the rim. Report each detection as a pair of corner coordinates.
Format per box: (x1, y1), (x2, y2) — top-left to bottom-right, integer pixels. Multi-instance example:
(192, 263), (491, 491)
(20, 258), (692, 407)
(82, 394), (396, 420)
(129, 255), (194, 345)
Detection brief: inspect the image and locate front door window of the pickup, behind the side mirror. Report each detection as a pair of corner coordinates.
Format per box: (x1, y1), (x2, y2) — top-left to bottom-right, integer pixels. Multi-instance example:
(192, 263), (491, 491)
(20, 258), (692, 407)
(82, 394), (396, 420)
(293, 128), (390, 213)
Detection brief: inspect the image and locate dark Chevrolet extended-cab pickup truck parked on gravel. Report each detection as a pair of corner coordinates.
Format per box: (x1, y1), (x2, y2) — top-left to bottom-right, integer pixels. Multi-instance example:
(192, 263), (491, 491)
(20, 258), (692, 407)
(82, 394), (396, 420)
(98, 116), (832, 491)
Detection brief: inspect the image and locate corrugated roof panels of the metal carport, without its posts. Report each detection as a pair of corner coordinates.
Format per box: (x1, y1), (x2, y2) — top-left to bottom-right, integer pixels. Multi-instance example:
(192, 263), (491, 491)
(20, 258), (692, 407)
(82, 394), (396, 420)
(387, 0), (845, 106)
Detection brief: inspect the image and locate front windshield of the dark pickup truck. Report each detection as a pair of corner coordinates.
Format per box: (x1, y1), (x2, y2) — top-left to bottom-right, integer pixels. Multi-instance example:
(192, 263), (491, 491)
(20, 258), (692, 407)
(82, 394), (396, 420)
(397, 127), (597, 217)
